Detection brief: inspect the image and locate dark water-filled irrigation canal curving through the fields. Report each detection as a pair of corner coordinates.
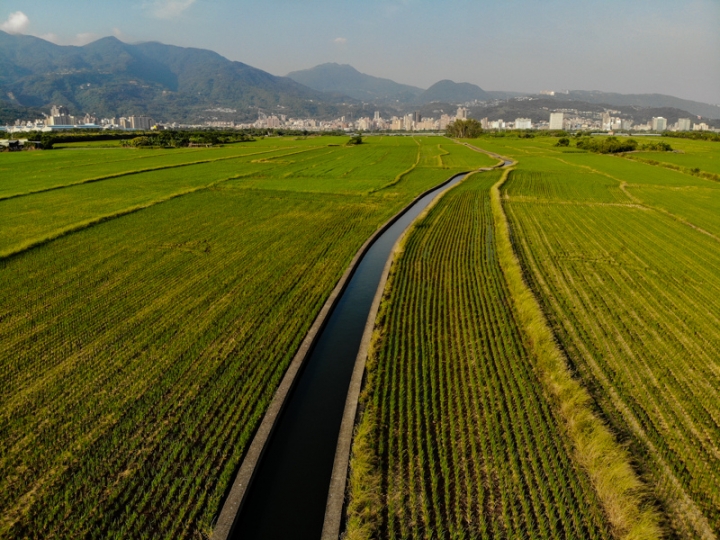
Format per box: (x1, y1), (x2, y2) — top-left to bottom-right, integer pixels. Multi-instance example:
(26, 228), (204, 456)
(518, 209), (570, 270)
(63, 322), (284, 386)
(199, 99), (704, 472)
(230, 167), (504, 540)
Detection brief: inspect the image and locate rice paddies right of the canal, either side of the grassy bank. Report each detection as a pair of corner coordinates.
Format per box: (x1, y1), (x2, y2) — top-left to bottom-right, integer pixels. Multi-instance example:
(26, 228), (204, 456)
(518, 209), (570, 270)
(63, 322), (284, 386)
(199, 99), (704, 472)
(347, 136), (720, 539)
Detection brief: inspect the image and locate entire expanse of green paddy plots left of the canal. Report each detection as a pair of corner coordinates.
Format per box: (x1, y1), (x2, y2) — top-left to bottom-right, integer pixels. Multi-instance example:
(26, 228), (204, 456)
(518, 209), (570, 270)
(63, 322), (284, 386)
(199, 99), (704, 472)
(0, 137), (495, 538)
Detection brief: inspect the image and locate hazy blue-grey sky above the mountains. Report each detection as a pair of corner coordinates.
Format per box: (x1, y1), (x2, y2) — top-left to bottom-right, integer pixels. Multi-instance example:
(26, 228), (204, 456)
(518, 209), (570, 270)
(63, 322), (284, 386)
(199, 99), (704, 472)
(0, 0), (720, 104)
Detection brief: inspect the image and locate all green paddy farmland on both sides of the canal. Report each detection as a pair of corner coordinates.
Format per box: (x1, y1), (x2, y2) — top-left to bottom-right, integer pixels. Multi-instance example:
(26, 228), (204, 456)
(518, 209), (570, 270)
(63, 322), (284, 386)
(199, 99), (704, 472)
(5, 132), (720, 540)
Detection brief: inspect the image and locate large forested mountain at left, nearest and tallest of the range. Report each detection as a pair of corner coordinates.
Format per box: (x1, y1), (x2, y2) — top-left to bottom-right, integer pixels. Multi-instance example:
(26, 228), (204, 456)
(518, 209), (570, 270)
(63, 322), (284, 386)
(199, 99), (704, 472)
(0, 32), (347, 121)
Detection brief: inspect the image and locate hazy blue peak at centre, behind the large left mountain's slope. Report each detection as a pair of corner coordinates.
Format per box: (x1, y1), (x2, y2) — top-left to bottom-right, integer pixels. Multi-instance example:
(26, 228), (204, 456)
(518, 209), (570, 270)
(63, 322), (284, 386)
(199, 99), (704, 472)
(287, 63), (423, 103)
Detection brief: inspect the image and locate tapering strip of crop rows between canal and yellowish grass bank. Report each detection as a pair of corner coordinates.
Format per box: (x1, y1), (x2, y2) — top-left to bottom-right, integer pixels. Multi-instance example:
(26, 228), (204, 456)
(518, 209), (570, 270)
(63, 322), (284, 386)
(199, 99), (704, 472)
(349, 173), (611, 539)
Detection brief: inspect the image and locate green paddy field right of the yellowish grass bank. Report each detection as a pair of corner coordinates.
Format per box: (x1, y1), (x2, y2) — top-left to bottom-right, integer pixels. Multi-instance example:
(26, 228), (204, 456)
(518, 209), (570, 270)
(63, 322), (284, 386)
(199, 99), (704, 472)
(492, 141), (720, 538)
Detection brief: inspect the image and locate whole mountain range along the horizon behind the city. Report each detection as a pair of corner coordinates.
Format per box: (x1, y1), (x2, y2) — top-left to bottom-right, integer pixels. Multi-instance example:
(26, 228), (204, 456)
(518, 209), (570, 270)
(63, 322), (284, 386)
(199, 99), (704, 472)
(0, 31), (720, 123)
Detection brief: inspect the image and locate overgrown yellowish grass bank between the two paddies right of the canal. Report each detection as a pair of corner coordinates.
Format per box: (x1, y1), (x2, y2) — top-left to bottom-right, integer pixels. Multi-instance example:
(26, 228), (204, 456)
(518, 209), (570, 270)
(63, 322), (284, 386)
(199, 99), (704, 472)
(490, 168), (663, 540)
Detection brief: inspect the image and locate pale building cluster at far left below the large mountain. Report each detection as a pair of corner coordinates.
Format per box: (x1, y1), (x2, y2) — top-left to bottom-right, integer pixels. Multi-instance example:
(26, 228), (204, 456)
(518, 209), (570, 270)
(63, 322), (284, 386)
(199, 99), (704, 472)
(5, 105), (155, 133)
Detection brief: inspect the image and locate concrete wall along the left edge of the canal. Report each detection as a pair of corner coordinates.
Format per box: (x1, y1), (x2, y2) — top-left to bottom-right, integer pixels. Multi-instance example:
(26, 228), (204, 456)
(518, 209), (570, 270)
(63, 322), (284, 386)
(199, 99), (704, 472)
(212, 169), (472, 540)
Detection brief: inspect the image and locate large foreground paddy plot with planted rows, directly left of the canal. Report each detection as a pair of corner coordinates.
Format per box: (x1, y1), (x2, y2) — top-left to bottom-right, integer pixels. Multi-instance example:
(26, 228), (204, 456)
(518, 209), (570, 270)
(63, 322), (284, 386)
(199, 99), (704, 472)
(0, 185), (404, 538)
